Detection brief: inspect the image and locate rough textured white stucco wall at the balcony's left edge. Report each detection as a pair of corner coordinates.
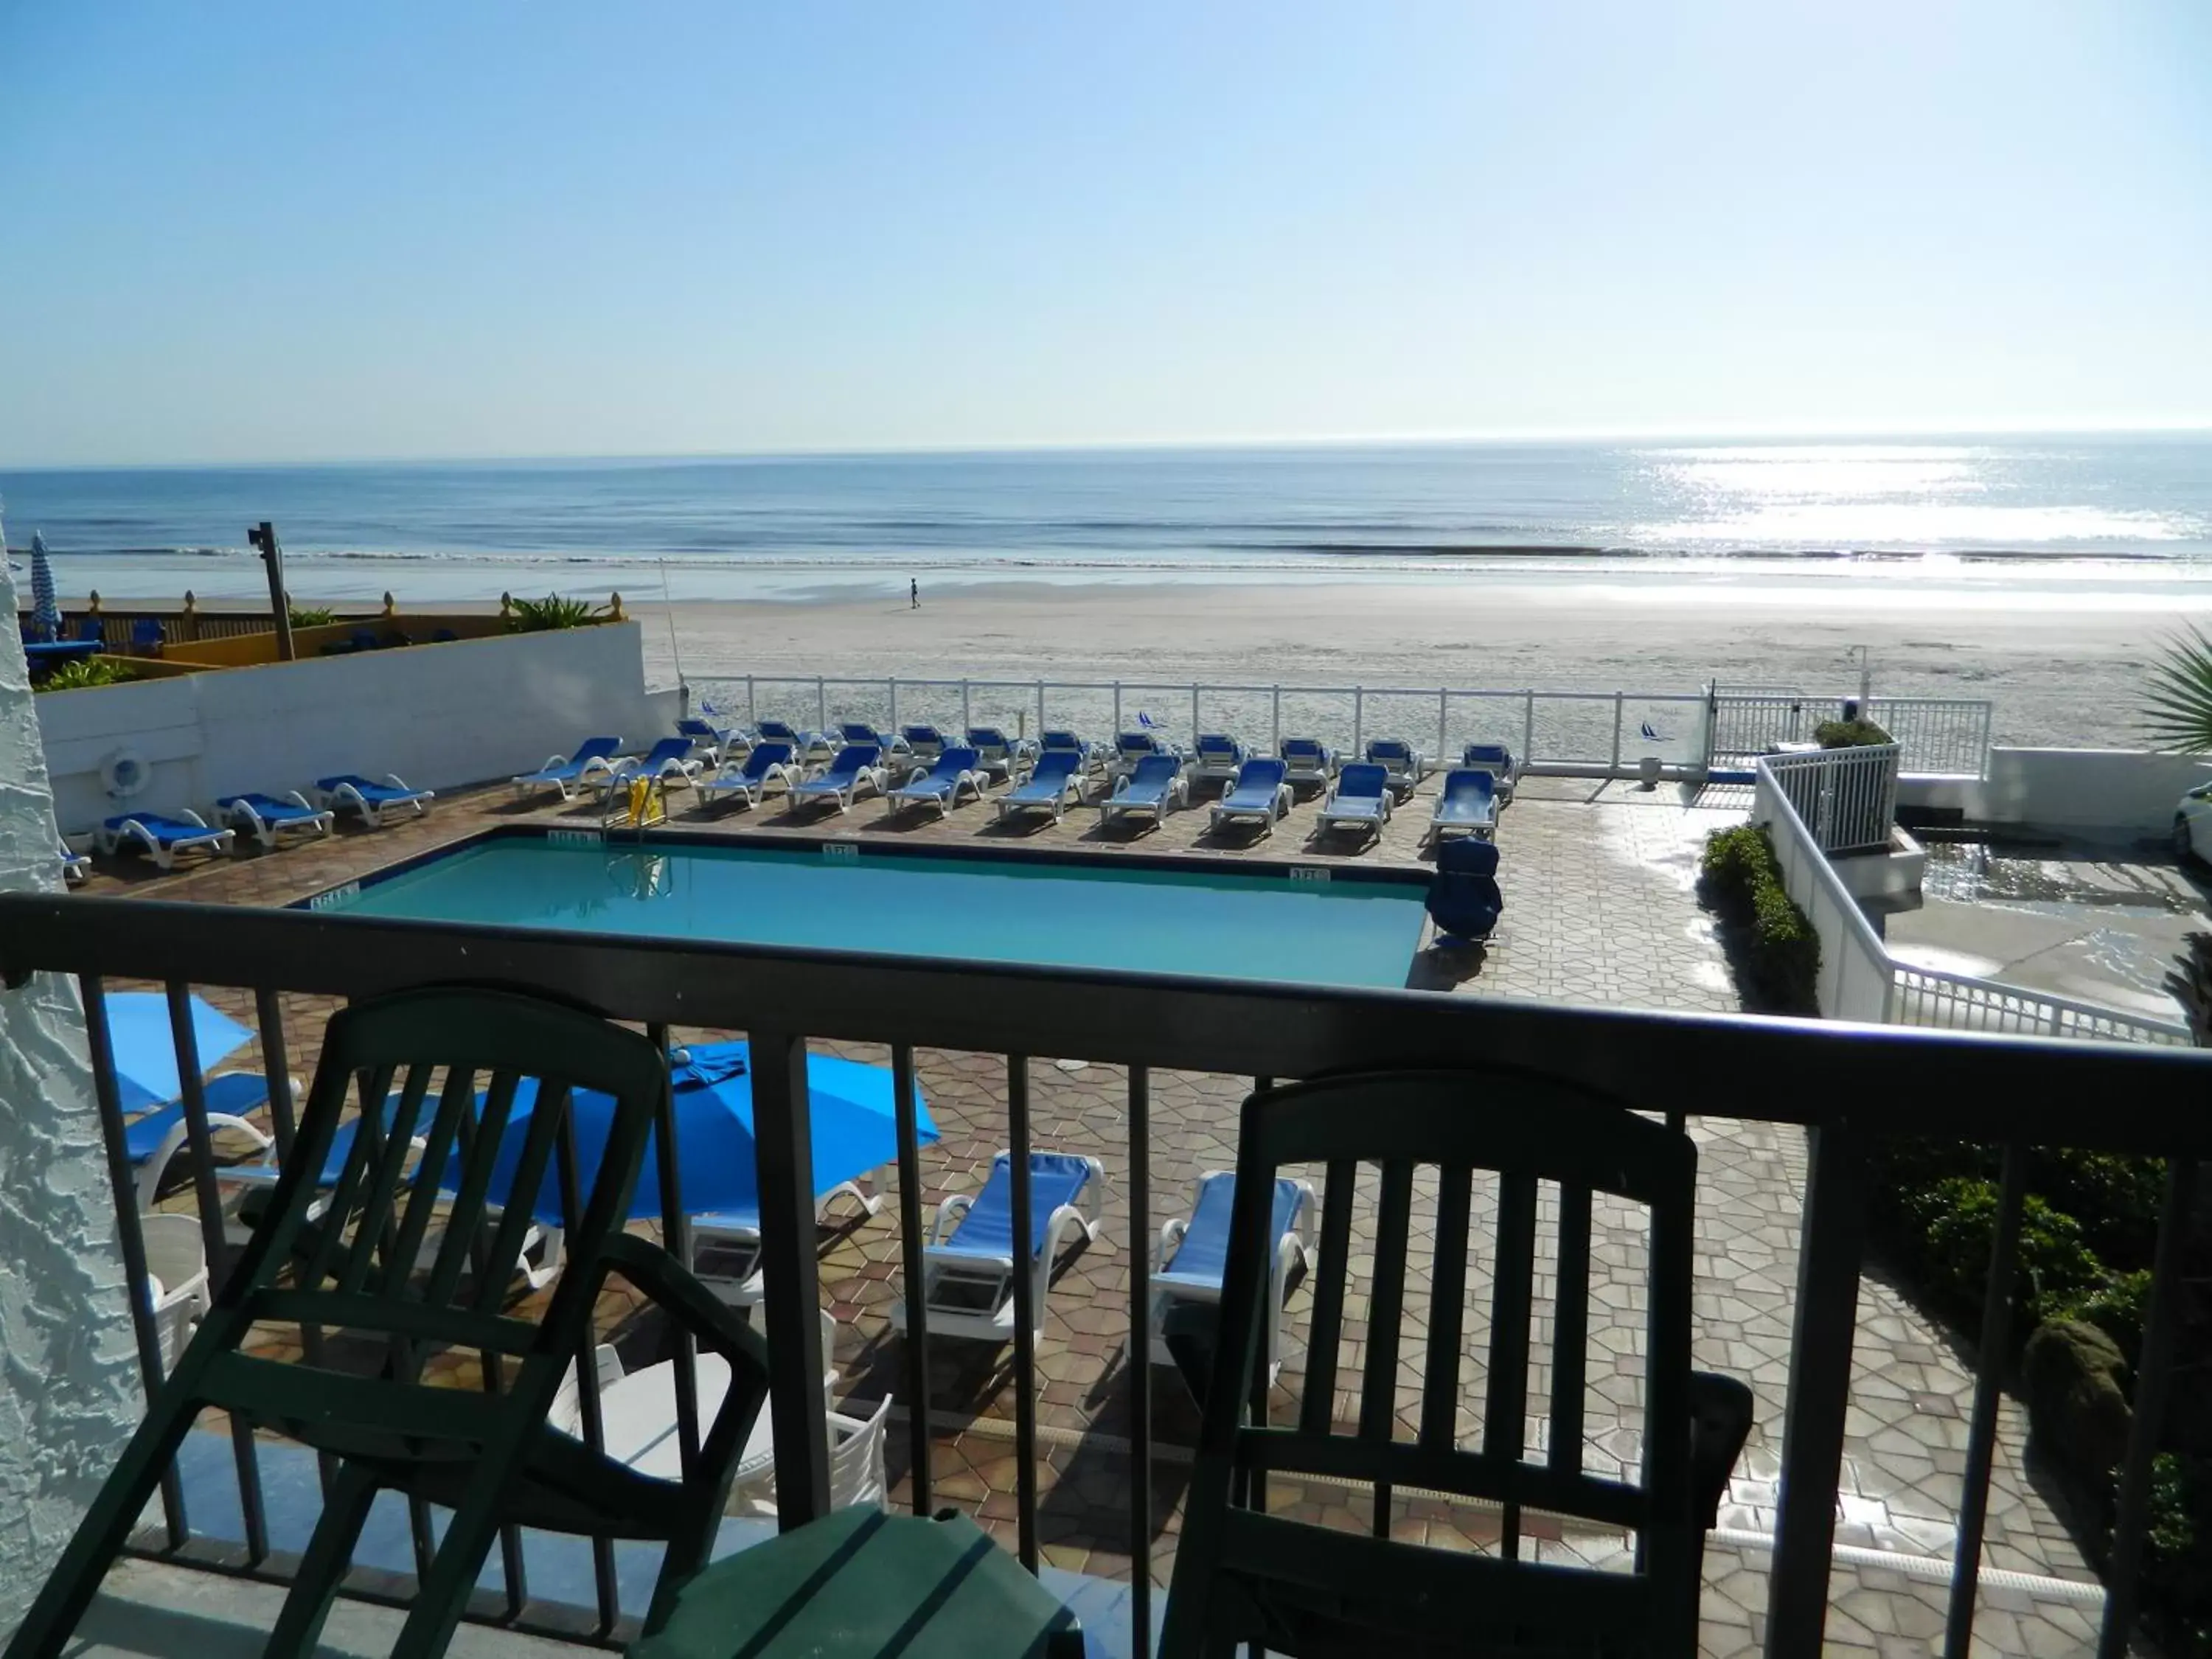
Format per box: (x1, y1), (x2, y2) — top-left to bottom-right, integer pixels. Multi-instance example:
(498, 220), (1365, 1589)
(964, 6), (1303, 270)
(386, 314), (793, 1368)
(0, 535), (142, 1635)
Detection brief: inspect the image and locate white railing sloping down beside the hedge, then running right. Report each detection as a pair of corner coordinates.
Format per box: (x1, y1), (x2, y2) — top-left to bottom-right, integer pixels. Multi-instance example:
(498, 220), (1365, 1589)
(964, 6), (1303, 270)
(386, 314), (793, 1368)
(1752, 757), (2190, 1044)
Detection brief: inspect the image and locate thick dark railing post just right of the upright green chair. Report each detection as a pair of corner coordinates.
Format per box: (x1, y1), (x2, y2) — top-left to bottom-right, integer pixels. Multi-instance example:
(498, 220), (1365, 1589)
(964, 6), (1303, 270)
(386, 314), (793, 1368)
(1765, 1124), (1865, 1659)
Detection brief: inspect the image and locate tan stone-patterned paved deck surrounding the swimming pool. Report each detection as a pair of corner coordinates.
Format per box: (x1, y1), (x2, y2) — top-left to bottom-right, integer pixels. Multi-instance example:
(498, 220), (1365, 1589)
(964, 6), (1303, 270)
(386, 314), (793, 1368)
(69, 779), (2097, 1655)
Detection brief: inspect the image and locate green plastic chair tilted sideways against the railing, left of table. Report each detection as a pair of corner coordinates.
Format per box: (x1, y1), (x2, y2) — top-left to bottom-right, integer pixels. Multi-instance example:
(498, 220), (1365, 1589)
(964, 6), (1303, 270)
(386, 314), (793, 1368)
(7, 989), (768, 1659)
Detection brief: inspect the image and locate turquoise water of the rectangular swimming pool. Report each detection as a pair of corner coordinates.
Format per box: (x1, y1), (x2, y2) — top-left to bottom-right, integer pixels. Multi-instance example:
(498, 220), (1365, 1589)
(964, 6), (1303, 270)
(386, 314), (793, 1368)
(316, 836), (1425, 987)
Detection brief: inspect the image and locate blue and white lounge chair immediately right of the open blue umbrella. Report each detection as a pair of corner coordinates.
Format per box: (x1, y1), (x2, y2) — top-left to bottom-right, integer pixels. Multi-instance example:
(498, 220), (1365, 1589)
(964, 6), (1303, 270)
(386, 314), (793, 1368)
(891, 1152), (1106, 1343)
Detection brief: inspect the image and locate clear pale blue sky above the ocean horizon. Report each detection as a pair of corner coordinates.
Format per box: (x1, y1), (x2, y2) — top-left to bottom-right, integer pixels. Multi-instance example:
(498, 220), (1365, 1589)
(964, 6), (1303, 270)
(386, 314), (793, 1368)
(0, 0), (2212, 465)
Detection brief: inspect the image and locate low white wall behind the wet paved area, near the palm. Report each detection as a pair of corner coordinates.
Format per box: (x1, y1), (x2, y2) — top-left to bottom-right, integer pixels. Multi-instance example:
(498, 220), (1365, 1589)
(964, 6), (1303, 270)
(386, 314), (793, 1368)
(1898, 750), (2212, 836)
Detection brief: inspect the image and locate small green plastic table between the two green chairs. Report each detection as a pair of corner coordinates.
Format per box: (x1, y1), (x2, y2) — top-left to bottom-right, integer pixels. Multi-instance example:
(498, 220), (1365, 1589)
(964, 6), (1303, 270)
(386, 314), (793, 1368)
(630, 1506), (1084, 1659)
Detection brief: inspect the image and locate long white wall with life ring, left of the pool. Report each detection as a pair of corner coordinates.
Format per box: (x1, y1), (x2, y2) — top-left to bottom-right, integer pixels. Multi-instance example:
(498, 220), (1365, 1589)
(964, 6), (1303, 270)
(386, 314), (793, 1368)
(38, 622), (677, 834)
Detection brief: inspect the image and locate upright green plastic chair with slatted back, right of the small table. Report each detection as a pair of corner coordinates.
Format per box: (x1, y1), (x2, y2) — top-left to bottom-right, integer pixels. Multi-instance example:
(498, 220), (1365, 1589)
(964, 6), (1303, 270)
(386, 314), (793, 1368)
(1161, 1068), (1752, 1659)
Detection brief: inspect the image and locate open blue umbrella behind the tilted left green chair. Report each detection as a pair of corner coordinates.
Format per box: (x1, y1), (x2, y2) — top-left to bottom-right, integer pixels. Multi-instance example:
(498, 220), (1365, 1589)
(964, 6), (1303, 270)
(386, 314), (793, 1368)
(442, 1042), (938, 1225)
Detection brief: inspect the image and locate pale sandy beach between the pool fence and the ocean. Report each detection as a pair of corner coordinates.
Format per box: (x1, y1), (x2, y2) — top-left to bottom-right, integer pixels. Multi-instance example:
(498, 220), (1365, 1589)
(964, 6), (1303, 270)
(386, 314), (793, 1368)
(630, 580), (2183, 748)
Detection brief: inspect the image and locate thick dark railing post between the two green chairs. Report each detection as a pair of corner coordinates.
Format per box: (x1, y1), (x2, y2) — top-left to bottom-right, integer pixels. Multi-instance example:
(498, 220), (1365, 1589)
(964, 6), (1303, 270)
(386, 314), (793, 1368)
(748, 1031), (836, 1531)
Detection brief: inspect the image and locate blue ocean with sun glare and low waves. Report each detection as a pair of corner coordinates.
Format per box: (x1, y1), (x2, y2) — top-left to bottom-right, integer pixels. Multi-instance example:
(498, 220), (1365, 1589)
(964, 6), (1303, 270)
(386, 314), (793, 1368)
(0, 434), (2212, 604)
